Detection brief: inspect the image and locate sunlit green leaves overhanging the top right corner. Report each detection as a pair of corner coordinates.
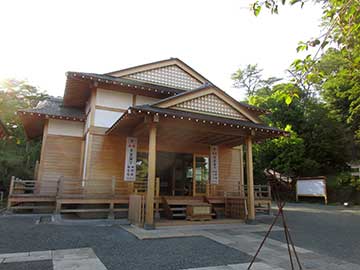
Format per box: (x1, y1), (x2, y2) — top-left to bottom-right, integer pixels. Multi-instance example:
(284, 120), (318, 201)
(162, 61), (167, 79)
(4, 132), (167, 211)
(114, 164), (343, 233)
(253, 0), (360, 140)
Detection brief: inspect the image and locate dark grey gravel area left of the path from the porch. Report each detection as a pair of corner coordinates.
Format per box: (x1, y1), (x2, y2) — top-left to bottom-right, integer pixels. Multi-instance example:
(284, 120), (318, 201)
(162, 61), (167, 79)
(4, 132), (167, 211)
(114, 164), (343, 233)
(0, 216), (250, 270)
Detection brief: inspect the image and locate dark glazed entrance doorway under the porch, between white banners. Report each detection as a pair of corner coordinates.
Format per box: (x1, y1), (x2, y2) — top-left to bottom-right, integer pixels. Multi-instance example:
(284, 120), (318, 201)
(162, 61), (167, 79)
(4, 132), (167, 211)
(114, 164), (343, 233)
(136, 152), (209, 196)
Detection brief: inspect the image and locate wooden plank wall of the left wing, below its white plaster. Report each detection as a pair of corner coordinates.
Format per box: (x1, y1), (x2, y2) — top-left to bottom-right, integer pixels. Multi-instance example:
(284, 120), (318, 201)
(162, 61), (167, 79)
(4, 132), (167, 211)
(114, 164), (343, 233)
(40, 135), (83, 195)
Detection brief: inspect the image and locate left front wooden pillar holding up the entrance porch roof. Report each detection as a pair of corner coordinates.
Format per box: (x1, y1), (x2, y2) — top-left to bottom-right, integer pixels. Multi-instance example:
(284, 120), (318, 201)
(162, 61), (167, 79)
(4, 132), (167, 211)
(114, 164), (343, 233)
(144, 125), (156, 229)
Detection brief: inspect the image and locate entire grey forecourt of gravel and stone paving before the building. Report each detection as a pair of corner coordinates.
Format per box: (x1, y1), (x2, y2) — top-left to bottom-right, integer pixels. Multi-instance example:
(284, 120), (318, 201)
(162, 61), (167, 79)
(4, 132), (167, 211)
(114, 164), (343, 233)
(0, 207), (360, 270)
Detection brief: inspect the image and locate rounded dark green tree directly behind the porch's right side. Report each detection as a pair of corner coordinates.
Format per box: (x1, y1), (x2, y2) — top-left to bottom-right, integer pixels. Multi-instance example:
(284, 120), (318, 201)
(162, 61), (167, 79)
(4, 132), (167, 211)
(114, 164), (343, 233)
(235, 66), (349, 179)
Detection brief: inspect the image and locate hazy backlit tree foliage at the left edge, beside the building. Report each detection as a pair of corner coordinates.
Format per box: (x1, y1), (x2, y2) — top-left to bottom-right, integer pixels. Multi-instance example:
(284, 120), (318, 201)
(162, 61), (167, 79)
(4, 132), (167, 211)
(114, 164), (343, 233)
(0, 79), (47, 189)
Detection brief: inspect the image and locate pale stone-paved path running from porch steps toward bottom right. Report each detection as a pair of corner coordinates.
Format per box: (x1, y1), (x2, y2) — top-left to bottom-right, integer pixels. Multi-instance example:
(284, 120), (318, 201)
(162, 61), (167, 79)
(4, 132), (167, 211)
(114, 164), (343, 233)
(123, 221), (360, 270)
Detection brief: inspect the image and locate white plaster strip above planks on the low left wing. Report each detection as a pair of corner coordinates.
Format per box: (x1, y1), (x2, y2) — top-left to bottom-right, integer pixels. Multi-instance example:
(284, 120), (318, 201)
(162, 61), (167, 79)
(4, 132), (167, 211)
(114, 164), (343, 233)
(48, 119), (84, 137)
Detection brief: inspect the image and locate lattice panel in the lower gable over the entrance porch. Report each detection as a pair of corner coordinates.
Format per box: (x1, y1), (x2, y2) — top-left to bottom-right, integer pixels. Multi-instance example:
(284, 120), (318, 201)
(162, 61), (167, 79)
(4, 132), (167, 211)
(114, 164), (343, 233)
(173, 94), (248, 121)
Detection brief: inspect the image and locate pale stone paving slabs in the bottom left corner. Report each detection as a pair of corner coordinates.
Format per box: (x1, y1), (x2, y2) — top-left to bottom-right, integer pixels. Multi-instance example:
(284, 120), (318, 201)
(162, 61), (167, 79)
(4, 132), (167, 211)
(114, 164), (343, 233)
(0, 248), (107, 270)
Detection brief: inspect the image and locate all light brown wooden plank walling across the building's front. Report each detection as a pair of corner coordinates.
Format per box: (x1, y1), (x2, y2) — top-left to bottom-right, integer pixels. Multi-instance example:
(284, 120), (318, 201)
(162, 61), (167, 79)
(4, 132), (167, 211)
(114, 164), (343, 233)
(40, 129), (240, 195)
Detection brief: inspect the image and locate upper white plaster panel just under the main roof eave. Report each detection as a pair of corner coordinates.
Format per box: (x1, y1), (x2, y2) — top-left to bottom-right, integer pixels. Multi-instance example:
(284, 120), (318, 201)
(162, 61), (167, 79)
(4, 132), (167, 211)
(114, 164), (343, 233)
(96, 88), (133, 109)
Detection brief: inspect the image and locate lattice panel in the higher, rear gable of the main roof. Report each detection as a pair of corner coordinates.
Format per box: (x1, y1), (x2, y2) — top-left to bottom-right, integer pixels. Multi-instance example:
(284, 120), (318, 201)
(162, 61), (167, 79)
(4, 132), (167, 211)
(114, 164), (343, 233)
(127, 65), (202, 90)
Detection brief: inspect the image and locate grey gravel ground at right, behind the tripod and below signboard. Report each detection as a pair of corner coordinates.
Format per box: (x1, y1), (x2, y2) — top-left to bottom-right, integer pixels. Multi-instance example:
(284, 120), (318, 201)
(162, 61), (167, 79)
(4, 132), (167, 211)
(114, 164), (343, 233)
(258, 204), (360, 264)
